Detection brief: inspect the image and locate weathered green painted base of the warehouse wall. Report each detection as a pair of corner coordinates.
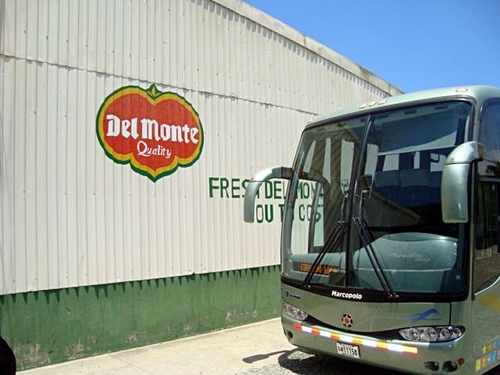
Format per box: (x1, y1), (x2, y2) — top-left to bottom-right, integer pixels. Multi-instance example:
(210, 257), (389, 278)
(0, 266), (280, 371)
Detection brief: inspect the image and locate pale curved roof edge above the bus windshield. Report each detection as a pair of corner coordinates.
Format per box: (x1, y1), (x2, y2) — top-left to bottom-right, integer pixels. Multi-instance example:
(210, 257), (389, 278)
(307, 86), (500, 127)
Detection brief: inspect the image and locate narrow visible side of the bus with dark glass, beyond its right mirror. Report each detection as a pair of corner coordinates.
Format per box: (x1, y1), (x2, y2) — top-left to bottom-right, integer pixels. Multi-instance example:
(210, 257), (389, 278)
(472, 100), (500, 372)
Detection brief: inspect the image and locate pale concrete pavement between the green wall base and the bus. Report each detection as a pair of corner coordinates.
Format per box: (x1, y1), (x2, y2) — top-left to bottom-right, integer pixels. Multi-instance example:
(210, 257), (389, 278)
(18, 319), (295, 375)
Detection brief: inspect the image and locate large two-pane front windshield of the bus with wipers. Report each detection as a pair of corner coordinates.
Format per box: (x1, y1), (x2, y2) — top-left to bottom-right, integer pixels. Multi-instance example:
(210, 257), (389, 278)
(282, 101), (472, 297)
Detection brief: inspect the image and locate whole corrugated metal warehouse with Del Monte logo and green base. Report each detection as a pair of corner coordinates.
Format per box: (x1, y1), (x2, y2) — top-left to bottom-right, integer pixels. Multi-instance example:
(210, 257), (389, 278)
(0, 0), (399, 370)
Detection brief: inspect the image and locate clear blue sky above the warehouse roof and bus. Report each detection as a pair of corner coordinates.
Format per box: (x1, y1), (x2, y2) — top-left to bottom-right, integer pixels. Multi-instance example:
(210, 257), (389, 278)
(244, 0), (500, 92)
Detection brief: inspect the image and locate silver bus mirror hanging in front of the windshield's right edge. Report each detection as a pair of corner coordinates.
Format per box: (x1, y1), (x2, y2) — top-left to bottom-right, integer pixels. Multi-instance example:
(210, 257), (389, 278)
(441, 142), (483, 223)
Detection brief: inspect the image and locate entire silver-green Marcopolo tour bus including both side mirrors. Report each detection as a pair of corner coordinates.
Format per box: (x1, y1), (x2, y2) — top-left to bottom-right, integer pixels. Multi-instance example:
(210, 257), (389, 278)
(244, 86), (500, 374)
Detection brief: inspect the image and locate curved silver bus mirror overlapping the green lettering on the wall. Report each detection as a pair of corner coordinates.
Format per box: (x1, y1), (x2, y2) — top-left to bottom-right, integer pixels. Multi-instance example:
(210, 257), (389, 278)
(243, 166), (293, 223)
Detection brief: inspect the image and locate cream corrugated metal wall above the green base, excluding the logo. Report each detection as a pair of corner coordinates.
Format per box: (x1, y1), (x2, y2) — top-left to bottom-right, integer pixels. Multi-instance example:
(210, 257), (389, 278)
(0, 0), (397, 294)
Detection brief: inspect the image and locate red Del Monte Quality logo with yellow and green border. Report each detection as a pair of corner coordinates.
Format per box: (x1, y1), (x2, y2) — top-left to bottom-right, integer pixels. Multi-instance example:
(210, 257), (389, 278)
(97, 84), (203, 181)
